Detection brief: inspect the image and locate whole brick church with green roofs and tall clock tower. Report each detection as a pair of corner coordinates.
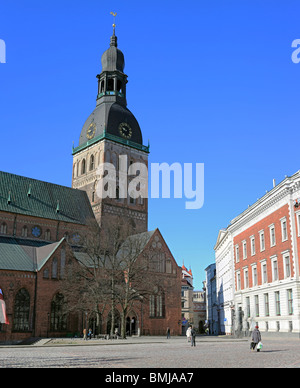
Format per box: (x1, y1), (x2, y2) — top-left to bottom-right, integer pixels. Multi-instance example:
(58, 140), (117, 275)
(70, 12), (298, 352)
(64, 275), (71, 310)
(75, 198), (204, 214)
(0, 28), (181, 342)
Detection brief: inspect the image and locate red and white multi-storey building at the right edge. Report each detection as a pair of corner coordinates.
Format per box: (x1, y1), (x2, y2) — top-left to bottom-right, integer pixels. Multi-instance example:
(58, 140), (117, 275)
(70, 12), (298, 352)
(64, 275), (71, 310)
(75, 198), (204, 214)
(227, 172), (300, 334)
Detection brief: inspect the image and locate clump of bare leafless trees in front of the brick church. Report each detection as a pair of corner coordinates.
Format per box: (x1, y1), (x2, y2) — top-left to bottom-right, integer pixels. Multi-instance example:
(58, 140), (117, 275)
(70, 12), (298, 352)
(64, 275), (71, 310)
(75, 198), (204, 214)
(64, 217), (157, 338)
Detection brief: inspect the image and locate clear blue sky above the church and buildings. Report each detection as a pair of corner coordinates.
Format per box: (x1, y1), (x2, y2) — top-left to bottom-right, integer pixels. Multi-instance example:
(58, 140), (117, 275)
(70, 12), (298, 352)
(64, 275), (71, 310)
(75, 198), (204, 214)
(0, 0), (300, 289)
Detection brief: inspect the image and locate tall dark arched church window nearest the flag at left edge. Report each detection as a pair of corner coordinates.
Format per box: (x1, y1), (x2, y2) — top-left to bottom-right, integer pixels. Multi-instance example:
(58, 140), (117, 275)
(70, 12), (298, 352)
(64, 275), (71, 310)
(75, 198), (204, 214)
(13, 288), (30, 331)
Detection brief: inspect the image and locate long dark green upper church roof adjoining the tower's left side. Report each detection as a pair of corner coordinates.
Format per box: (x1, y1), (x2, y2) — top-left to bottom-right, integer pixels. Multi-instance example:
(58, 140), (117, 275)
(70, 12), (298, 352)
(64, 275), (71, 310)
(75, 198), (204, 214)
(0, 171), (94, 224)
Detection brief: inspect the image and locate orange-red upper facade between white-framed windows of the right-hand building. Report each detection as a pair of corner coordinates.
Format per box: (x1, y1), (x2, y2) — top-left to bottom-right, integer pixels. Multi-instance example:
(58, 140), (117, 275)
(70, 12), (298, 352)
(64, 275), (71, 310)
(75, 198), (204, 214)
(234, 205), (294, 289)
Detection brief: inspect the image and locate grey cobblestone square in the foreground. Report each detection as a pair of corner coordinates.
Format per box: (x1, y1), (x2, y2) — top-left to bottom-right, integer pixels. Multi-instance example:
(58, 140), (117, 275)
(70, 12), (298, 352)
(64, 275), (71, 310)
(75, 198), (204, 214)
(0, 337), (300, 370)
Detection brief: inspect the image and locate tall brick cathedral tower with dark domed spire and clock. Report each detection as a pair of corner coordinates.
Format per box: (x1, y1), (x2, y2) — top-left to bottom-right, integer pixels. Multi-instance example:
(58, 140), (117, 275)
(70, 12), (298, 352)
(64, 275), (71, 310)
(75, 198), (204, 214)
(72, 25), (149, 233)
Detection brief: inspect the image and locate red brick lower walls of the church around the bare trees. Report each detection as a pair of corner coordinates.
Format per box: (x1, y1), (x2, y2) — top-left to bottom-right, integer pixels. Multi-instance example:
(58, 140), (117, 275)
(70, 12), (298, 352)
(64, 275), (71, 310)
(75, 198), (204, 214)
(0, 226), (181, 342)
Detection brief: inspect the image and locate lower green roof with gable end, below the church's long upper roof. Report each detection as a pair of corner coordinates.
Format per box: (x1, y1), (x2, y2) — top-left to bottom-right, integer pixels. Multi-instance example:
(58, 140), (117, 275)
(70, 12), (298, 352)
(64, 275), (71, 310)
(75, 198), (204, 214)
(0, 237), (65, 272)
